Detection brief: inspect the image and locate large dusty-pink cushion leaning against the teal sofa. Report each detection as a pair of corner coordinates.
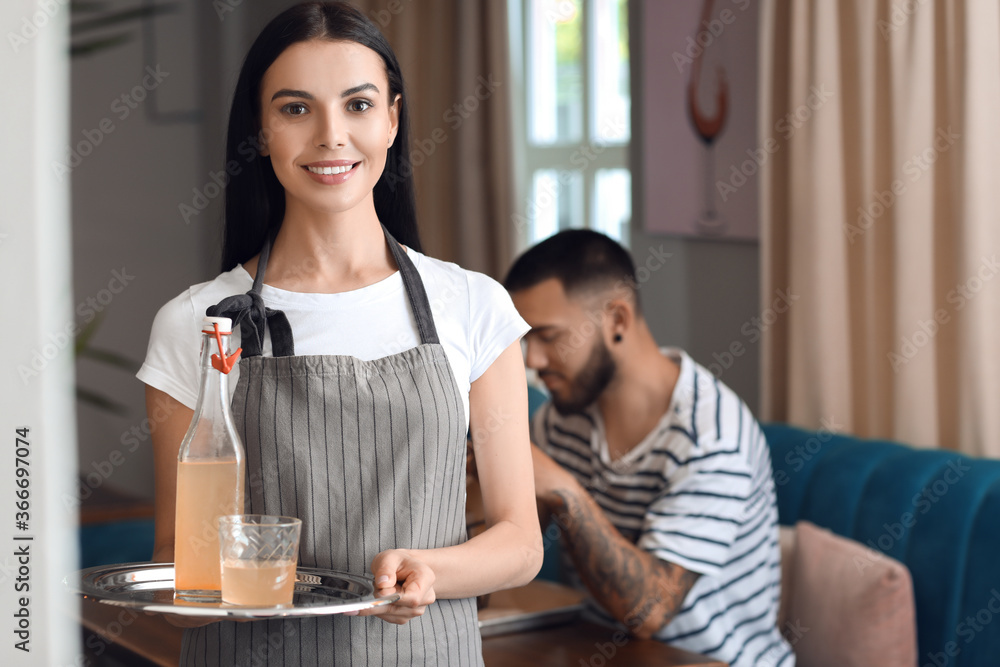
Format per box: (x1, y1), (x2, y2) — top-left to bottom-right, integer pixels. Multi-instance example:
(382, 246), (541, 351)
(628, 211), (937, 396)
(781, 521), (917, 667)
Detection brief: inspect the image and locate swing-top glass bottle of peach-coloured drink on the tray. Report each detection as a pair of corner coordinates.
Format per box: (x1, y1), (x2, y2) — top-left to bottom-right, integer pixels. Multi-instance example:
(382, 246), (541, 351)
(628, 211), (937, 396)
(174, 317), (245, 598)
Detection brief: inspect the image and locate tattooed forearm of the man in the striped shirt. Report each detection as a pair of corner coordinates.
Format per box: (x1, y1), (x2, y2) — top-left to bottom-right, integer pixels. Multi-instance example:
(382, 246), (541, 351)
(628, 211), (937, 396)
(531, 445), (698, 638)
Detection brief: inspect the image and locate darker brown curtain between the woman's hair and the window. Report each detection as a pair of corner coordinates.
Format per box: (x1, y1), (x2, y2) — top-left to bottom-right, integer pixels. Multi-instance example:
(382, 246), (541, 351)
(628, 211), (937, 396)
(352, 0), (514, 278)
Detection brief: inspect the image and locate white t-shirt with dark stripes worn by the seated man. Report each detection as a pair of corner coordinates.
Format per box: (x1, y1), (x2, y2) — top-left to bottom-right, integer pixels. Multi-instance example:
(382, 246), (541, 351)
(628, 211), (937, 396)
(532, 348), (795, 667)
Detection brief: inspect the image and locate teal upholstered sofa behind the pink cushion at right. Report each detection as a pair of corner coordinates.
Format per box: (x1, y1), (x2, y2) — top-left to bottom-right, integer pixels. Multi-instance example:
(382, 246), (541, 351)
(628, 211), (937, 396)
(763, 424), (1000, 667)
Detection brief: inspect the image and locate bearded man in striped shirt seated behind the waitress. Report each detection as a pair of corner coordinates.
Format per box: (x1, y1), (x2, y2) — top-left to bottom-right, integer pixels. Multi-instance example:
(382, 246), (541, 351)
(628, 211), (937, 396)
(504, 230), (795, 667)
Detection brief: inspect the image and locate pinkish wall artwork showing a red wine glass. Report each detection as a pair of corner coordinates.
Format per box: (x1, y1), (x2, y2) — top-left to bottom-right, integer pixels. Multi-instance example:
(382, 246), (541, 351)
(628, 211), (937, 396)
(639, 0), (760, 241)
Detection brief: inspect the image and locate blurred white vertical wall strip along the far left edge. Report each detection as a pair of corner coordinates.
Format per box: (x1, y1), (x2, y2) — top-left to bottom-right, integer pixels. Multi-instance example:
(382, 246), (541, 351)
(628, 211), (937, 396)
(0, 0), (79, 665)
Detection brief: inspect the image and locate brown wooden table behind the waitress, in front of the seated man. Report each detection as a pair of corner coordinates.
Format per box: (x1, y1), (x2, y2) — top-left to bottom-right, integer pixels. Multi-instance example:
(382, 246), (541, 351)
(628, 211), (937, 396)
(81, 581), (725, 667)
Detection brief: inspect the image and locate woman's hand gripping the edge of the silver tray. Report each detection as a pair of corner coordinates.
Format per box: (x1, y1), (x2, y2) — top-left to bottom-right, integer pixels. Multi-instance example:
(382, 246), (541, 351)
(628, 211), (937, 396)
(352, 549), (436, 625)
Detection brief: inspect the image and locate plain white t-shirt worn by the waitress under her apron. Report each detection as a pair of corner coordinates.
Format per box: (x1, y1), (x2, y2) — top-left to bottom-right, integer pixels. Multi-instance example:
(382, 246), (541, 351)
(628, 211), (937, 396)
(143, 249), (529, 424)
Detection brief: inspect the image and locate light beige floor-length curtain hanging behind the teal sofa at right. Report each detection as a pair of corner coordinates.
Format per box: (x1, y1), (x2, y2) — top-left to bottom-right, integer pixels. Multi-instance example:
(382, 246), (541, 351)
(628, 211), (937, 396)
(759, 0), (1000, 457)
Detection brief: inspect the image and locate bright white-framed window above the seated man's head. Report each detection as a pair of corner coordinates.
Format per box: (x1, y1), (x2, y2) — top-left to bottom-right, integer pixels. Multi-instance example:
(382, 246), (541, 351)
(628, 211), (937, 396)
(508, 0), (632, 251)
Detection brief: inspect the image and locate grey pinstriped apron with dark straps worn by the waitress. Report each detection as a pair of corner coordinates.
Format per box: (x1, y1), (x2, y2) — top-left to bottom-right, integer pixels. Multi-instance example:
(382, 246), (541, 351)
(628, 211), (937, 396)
(181, 231), (482, 667)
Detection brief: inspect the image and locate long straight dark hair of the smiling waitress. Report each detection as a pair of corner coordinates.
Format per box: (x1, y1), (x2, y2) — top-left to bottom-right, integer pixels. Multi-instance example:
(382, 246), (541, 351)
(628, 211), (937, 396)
(222, 2), (421, 271)
